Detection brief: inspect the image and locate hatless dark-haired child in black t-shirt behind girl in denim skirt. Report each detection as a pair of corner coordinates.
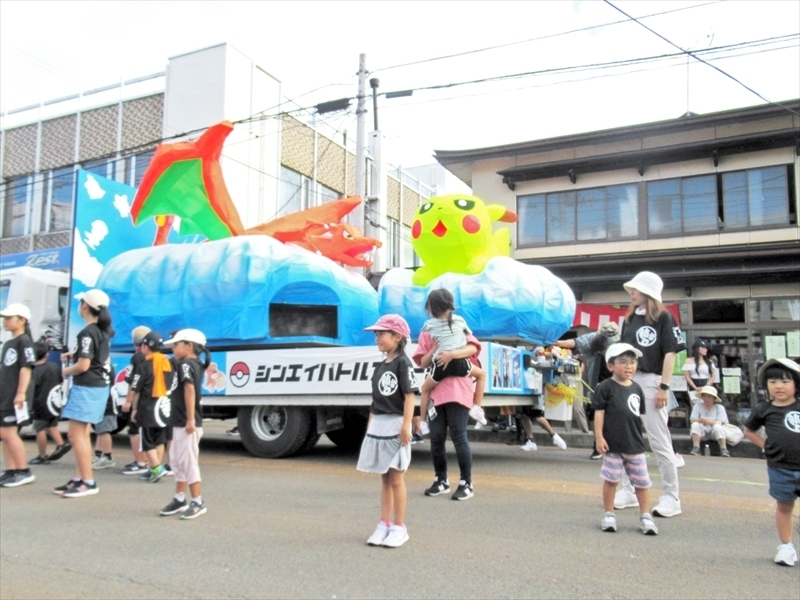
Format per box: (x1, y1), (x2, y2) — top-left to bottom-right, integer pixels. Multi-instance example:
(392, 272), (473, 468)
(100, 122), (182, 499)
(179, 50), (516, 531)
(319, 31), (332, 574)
(31, 342), (72, 465)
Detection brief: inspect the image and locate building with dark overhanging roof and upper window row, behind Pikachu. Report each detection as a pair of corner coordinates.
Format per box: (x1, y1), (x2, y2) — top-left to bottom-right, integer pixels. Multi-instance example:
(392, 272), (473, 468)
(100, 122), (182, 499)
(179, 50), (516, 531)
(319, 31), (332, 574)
(436, 100), (800, 406)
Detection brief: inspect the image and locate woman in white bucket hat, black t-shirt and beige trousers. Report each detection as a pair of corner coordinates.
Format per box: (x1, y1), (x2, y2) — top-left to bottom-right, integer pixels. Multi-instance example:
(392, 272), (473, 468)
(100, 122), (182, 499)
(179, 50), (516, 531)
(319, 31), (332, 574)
(614, 271), (683, 517)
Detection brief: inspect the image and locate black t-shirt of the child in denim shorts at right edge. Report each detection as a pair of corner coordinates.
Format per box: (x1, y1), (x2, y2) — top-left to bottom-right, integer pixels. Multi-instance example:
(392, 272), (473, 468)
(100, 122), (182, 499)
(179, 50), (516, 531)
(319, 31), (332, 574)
(745, 400), (800, 471)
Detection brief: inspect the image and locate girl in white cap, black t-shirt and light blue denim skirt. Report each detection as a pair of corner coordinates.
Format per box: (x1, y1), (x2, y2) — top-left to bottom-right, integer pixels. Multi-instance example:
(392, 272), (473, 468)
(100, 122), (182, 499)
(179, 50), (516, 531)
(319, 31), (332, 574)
(53, 289), (114, 498)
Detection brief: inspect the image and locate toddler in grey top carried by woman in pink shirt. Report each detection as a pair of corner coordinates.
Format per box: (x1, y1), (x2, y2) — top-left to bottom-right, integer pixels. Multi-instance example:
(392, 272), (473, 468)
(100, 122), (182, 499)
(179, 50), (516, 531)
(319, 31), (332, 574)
(420, 289), (486, 425)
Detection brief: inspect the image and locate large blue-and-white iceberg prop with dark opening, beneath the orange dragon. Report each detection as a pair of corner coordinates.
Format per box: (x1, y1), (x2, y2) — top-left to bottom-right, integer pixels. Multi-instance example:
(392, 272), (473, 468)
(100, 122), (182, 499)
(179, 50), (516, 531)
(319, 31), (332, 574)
(97, 236), (379, 349)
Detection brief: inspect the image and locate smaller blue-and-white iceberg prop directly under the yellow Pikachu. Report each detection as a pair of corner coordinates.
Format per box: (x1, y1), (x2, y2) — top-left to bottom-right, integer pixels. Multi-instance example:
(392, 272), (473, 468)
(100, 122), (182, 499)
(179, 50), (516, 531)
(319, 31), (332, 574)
(378, 256), (575, 344)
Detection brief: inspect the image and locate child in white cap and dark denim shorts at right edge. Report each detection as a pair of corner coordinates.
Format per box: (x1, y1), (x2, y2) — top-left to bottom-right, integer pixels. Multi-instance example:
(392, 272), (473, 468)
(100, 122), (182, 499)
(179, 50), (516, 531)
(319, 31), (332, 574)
(744, 358), (800, 567)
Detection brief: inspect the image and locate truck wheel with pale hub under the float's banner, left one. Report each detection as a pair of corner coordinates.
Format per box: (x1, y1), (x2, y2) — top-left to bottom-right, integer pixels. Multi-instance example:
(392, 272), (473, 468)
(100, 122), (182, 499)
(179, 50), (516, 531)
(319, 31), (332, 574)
(238, 405), (311, 458)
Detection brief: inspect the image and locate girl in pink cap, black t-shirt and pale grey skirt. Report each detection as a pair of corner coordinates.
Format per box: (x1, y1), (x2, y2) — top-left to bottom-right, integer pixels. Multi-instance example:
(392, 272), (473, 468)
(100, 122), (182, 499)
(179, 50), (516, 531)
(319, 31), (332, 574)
(356, 315), (416, 548)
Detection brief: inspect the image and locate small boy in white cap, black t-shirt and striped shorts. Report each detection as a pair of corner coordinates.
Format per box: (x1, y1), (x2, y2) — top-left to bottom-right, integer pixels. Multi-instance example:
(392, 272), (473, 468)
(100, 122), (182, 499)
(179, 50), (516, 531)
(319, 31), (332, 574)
(592, 344), (658, 535)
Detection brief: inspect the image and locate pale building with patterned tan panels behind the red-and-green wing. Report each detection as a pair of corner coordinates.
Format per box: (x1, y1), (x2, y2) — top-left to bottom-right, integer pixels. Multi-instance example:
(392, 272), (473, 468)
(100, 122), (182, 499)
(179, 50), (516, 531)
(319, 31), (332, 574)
(0, 44), (443, 271)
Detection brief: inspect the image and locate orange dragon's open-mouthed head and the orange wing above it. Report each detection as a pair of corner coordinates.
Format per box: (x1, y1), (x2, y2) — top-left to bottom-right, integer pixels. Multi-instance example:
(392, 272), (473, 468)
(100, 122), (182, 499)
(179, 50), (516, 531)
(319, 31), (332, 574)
(245, 196), (381, 267)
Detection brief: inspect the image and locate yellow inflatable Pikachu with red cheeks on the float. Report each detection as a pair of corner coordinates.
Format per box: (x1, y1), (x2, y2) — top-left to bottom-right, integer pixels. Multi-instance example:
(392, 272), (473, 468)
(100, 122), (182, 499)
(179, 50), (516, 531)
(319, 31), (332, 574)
(411, 194), (517, 286)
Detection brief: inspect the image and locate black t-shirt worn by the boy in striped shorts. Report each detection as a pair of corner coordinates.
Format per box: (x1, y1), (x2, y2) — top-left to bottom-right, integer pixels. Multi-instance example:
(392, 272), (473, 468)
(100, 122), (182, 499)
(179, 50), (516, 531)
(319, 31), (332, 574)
(592, 379), (645, 454)
